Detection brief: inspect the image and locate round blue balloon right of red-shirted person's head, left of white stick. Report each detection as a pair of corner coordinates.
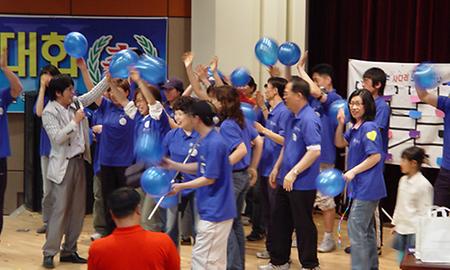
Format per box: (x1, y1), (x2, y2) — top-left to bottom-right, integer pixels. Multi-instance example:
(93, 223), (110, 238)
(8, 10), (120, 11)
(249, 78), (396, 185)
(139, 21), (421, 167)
(141, 167), (174, 197)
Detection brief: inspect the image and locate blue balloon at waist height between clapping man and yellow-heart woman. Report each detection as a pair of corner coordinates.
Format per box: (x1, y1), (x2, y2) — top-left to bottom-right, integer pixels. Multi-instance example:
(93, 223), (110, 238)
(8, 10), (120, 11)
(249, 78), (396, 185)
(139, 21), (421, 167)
(316, 169), (345, 197)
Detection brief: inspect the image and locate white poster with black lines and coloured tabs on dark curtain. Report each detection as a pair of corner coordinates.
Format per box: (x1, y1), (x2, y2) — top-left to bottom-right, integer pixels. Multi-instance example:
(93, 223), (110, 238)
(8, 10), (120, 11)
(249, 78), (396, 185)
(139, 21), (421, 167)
(348, 59), (450, 168)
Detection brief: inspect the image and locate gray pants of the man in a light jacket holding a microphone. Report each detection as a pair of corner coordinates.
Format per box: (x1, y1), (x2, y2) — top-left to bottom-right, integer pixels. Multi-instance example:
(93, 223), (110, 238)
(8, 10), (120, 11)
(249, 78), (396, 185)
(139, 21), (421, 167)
(42, 158), (86, 256)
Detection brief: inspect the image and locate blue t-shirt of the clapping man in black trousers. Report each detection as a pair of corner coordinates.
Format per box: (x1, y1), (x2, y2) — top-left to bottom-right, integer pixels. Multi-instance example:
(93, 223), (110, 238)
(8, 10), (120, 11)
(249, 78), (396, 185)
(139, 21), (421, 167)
(277, 105), (321, 190)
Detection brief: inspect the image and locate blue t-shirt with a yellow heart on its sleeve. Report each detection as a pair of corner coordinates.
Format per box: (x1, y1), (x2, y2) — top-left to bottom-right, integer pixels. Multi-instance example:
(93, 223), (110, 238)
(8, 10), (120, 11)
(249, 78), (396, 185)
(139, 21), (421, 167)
(344, 121), (386, 201)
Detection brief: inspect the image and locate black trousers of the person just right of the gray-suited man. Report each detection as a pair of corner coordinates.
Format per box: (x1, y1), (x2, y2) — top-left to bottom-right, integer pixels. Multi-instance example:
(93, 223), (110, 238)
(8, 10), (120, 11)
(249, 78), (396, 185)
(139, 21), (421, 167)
(100, 165), (127, 235)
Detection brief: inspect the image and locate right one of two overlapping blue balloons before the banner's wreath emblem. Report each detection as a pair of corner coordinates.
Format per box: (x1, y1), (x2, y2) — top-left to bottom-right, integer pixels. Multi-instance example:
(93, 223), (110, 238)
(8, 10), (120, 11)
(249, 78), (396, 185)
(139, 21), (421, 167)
(136, 54), (166, 85)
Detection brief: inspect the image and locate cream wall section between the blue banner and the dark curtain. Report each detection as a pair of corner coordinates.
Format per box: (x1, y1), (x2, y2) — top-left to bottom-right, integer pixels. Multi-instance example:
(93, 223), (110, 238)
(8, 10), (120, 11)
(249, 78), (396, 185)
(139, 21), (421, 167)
(191, 0), (307, 90)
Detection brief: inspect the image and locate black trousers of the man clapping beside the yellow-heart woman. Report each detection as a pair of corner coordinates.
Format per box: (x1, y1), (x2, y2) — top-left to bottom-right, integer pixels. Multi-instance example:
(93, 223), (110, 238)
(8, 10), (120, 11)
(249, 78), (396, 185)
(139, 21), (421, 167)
(270, 185), (319, 268)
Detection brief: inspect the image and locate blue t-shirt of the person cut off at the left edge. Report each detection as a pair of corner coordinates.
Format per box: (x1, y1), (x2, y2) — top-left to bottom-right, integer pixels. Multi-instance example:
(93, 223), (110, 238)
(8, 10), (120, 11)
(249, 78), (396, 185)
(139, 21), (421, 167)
(0, 88), (14, 158)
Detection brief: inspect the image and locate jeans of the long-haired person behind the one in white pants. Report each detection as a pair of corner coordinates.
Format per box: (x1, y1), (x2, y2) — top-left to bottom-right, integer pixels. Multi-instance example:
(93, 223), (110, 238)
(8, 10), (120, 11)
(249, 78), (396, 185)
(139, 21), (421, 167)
(227, 171), (250, 270)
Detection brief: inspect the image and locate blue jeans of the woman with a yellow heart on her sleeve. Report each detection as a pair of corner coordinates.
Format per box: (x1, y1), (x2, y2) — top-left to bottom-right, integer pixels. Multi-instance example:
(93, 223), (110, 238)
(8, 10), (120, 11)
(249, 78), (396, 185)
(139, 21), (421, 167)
(348, 200), (378, 270)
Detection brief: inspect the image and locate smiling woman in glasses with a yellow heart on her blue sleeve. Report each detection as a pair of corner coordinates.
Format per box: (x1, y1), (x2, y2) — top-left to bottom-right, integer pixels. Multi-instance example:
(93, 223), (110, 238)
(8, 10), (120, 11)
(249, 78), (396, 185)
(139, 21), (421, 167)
(335, 89), (386, 269)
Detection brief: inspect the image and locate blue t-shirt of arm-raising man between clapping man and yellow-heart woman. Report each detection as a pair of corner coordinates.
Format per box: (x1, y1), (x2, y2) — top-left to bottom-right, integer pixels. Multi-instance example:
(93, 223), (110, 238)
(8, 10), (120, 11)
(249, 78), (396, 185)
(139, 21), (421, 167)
(310, 89), (342, 164)
